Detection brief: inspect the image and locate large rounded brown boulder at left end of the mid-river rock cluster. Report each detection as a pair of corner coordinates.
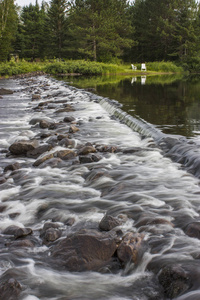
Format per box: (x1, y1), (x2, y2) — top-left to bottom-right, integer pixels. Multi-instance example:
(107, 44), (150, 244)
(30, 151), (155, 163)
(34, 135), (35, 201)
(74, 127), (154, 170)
(9, 140), (39, 155)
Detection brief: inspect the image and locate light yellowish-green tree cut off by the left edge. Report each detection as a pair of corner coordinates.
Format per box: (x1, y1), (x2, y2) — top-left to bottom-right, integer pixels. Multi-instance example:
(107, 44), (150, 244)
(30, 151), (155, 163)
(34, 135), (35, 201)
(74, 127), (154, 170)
(0, 0), (18, 61)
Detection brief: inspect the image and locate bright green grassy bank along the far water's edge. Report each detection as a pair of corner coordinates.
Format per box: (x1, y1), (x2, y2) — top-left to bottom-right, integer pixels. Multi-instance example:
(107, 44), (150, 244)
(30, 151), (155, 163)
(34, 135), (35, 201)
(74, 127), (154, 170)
(0, 60), (183, 76)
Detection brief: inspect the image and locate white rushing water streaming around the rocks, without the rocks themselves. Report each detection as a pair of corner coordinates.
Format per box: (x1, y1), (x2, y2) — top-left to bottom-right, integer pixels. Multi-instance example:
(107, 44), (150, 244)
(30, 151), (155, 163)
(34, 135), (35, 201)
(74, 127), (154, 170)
(0, 77), (200, 300)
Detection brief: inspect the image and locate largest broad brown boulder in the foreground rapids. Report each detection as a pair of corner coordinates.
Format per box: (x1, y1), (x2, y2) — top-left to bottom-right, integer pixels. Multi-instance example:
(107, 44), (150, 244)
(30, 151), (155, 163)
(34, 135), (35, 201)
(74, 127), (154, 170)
(51, 230), (117, 272)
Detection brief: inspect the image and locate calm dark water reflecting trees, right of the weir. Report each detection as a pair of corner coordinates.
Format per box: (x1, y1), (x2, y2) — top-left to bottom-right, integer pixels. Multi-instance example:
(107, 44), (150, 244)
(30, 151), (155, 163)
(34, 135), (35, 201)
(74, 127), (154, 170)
(65, 75), (200, 137)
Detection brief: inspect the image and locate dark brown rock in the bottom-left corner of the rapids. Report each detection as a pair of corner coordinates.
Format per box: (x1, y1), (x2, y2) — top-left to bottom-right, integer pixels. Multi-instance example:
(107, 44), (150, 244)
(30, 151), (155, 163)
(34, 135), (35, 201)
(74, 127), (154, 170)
(0, 278), (22, 300)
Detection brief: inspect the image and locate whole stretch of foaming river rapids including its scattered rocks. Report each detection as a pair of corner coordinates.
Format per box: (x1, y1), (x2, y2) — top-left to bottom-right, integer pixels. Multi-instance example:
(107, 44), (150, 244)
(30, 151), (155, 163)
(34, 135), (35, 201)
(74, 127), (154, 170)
(0, 76), (200, 300)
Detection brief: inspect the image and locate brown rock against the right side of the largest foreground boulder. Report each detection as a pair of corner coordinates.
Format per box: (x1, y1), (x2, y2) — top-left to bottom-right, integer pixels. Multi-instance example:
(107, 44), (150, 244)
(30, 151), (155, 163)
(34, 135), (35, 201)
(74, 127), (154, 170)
(117, 232), (144, 265)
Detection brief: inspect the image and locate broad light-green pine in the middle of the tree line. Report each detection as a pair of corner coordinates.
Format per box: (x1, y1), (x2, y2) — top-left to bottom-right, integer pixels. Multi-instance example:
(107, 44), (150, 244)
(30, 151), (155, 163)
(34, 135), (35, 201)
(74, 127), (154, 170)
(70, 0), (132, 61)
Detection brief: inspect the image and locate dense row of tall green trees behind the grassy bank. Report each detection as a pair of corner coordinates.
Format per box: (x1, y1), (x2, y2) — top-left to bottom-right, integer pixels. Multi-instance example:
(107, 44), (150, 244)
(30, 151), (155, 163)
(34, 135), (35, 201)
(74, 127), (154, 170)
(0, 0), (200, 64)
